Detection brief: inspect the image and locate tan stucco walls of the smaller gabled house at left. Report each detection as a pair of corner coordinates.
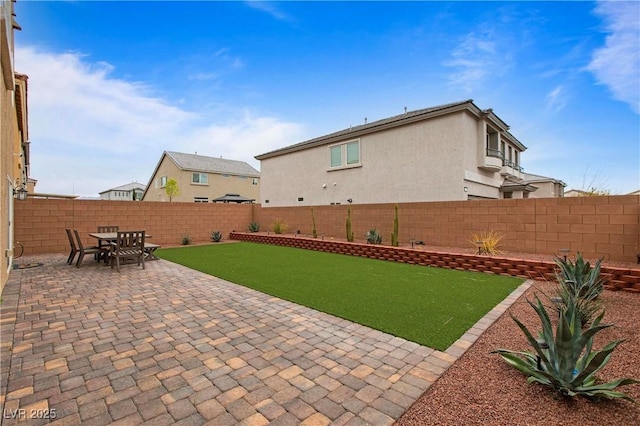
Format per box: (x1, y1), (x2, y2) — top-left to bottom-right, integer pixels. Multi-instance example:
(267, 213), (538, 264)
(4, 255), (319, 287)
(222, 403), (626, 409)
(143, 156), (260, 203)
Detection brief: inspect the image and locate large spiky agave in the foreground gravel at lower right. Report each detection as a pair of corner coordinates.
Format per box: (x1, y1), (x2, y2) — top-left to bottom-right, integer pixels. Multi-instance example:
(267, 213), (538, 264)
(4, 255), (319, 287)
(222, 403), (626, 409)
(493, 297), (640, 402)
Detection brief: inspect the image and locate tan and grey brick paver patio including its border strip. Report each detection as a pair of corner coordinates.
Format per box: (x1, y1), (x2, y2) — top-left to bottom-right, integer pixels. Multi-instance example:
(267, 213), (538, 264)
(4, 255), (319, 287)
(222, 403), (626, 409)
(0, 254), (530, 426)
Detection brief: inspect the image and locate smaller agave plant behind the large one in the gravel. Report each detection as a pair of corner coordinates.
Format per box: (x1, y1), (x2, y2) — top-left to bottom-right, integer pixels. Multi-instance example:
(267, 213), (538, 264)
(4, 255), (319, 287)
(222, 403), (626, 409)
(554, 252), (606, 300)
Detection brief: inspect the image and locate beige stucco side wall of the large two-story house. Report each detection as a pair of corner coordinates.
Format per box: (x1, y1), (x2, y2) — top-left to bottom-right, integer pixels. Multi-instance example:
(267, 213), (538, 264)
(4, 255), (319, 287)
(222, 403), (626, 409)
(260, 111), (502, 207)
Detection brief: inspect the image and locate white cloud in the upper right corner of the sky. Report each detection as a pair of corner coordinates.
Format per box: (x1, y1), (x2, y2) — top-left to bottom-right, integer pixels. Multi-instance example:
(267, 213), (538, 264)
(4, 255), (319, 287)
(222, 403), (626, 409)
(587, 1), (640, 114)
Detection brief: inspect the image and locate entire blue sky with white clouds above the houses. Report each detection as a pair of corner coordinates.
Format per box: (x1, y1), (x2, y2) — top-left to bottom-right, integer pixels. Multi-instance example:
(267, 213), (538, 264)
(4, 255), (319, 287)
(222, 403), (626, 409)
(15, 0), (640, 196)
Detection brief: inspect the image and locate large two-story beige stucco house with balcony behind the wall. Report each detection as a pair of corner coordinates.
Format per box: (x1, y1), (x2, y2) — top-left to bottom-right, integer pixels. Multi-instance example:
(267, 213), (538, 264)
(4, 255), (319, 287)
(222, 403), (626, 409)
(255, 100), (560, 207)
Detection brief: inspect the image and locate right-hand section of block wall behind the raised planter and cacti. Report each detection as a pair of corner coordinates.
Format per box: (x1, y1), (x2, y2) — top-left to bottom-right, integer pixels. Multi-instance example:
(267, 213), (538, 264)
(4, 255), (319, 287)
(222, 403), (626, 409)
(254, 195), (640, 263)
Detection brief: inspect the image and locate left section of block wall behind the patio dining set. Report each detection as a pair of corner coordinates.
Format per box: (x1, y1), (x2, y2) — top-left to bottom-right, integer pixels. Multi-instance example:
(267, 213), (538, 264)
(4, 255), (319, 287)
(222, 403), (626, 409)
(15, 198), (253, 255)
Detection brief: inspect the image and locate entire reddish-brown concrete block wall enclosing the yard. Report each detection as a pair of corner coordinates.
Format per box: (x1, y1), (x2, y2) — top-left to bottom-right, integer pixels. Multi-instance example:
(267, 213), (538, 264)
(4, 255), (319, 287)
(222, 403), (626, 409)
(14, 195), (640, 263)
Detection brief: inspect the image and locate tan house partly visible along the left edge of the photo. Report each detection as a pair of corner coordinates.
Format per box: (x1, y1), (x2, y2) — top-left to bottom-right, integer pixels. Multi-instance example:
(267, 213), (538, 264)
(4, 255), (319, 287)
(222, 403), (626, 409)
(0, 0), (29, 293)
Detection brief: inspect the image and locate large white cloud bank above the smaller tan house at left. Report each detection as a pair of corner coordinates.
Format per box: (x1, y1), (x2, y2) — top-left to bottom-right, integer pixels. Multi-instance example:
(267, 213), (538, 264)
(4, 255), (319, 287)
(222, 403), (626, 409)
(15, 47), (303, 195)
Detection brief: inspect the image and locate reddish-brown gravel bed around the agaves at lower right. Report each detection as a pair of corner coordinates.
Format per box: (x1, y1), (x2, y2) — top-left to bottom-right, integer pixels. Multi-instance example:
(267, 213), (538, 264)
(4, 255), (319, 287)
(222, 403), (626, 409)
(396, 282), (640, 426)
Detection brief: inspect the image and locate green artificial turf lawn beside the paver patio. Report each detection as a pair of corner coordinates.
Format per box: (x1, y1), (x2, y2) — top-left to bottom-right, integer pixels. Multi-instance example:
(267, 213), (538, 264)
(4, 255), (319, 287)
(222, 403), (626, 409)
(157, 243), (522, 350)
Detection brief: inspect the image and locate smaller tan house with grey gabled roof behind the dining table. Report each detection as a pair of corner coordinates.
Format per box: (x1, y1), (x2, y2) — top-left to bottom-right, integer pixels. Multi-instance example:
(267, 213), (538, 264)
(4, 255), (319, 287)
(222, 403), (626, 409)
(142, 151), (260, 203)
